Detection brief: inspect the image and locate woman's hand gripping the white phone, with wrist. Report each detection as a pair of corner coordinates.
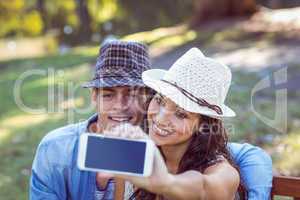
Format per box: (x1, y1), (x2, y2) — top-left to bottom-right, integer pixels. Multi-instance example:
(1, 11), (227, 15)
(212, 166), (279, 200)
(103, 124), (172, 194)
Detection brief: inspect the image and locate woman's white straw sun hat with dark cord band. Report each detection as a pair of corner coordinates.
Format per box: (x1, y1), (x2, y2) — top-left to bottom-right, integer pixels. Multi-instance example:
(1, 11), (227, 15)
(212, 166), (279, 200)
(142, 48), (235, 118)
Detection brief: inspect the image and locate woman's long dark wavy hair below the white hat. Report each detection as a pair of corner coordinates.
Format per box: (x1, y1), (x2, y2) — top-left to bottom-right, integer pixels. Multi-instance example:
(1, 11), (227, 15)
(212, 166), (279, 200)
(130, 115), (247, 200)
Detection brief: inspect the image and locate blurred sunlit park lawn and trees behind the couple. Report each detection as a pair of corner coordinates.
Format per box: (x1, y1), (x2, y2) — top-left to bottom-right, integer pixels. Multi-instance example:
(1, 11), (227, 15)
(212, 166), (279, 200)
(0, 0), (300, 200)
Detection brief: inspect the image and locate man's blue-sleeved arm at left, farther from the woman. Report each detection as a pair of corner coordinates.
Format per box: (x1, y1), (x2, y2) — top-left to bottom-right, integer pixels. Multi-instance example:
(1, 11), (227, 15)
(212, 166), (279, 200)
(29, 144), (66, 200)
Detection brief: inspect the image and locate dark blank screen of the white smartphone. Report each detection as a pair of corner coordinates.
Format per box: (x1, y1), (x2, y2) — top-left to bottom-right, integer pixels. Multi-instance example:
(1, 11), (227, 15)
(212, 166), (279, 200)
(85, 136), (146, 174)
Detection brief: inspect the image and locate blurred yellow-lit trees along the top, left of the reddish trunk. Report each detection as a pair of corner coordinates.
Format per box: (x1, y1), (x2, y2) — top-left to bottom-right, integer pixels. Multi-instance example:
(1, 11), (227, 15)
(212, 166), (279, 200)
(0, 0), (193, 43)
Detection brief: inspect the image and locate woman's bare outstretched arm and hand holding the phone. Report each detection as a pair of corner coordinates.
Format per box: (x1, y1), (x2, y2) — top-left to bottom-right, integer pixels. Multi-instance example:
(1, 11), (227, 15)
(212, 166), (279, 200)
(105, 125), (239, 200)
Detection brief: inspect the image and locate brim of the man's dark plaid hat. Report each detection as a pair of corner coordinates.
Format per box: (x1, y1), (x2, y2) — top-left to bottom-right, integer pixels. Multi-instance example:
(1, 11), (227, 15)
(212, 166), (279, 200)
(81, 77), (146, 88)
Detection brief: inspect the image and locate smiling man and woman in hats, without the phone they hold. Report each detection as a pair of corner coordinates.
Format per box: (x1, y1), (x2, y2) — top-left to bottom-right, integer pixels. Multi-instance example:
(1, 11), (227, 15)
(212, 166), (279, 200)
(30, 41), (272, 200)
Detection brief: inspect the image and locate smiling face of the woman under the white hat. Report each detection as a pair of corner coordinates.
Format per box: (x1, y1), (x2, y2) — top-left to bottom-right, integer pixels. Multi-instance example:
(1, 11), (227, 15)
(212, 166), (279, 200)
(148, 94), (200, 146)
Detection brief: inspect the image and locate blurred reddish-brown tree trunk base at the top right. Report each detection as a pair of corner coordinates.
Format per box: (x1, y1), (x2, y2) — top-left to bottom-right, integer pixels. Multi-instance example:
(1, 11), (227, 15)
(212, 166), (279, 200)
(191, 0), (257, 25)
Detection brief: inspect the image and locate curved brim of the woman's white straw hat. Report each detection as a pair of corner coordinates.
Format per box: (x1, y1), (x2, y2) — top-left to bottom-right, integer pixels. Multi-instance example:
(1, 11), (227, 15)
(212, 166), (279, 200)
(142, 69), (236, 118)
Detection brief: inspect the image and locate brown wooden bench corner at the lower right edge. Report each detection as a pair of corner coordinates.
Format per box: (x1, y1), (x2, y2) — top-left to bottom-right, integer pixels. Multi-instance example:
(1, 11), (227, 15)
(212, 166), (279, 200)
(271, 176), (300, 200)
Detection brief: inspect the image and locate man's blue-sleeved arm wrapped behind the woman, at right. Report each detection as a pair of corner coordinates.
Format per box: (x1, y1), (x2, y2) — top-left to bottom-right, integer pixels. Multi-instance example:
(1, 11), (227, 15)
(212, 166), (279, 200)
(228, 143), (273, 200)
